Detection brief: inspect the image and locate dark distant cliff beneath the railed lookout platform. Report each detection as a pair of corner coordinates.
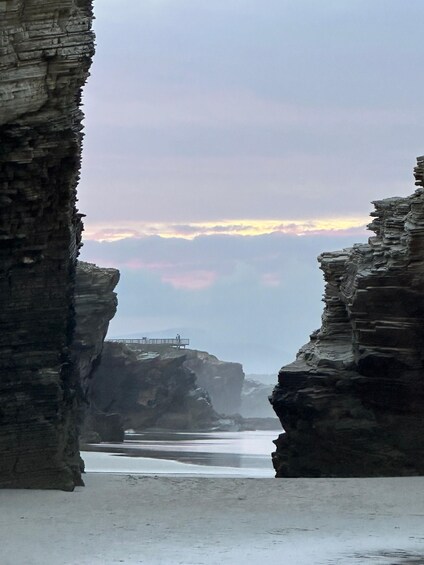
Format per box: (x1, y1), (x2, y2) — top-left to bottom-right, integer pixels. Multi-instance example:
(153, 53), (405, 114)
(88, 342), (217, 441)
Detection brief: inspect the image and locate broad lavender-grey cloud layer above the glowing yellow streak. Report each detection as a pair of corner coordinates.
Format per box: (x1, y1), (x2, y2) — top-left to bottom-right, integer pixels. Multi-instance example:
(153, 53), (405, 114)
(80, 0), (424, 227)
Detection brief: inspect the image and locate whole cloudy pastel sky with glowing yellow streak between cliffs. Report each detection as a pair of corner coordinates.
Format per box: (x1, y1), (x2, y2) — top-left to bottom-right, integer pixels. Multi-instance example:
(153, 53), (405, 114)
(79, 0), (424, 373)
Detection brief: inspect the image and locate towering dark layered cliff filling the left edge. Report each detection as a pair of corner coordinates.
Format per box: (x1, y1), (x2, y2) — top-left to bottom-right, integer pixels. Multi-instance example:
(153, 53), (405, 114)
(0, 0), (93, 489)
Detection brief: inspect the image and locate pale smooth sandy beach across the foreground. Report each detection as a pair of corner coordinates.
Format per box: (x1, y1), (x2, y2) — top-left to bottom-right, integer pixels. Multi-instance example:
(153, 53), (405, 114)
(0, 473), (424, 565)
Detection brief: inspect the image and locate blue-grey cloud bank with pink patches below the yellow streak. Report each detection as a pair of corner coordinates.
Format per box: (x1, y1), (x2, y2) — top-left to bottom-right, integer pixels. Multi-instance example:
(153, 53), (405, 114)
(82, 229), (364, 372)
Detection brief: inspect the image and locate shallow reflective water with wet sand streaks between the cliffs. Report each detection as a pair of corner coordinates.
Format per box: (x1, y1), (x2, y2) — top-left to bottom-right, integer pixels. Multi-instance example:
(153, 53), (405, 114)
(82, 430), (281, 477)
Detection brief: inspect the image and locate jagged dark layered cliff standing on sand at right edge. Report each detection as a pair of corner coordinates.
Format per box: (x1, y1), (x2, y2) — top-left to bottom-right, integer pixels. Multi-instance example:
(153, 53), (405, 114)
(271, 157), (424, 477)
